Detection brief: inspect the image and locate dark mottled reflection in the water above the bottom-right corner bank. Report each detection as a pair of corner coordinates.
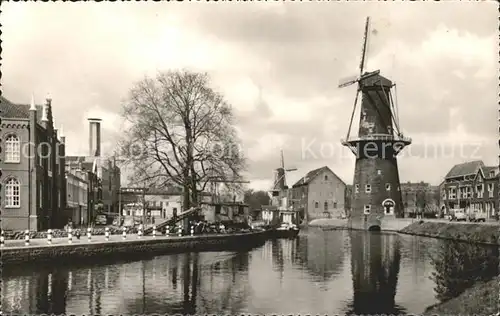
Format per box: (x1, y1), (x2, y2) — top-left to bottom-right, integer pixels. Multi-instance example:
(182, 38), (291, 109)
(431, 240), (499, 301)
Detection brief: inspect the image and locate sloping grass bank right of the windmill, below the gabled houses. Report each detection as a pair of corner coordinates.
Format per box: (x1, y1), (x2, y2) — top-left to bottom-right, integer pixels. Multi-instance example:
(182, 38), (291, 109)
(399, 221), (500, 245)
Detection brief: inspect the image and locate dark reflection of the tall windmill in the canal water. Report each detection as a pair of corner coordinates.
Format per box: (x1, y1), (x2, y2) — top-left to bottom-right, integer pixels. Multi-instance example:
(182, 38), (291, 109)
(347, 232), (406, 315)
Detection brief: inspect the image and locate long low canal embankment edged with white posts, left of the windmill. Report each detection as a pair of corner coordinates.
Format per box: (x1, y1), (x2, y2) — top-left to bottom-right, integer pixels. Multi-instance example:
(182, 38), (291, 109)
(1, 231), (267, 265)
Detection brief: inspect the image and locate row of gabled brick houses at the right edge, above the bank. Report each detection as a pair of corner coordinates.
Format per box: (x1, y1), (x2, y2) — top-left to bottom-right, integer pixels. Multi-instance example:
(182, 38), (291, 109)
(442, 160), (499, 218)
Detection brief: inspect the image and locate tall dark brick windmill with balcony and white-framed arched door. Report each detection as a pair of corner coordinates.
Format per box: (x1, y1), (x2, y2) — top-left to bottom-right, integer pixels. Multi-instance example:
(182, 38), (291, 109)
(339, 17), (411, 230)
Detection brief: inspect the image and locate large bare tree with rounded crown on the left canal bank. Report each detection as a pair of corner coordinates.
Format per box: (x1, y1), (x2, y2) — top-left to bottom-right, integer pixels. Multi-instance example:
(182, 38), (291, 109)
(121, 70), (245, 210)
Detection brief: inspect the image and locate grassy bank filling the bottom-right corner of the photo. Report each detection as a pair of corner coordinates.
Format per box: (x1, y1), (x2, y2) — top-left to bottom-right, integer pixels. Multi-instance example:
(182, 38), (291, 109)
(424, 278), (500, 315)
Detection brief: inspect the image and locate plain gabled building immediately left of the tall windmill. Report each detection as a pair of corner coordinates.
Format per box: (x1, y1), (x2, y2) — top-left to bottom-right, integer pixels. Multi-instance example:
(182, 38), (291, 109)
(291, 166), (348, 222)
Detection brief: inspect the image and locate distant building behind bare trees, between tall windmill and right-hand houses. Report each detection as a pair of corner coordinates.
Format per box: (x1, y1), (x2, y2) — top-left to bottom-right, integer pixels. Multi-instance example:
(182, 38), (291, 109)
(400, 181), (440, 217)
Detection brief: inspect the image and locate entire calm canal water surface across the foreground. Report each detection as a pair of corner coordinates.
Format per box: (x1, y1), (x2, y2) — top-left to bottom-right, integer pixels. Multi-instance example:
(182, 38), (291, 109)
(2, 229), (499, 315)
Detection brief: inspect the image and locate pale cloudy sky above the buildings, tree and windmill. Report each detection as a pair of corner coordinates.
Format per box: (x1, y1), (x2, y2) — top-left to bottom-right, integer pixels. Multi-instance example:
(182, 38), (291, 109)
(0, 2), (498, 189)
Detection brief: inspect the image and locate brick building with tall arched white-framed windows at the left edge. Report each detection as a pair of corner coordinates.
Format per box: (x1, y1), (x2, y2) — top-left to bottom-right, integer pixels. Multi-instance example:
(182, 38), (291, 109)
(0, 97), (66, 231)
